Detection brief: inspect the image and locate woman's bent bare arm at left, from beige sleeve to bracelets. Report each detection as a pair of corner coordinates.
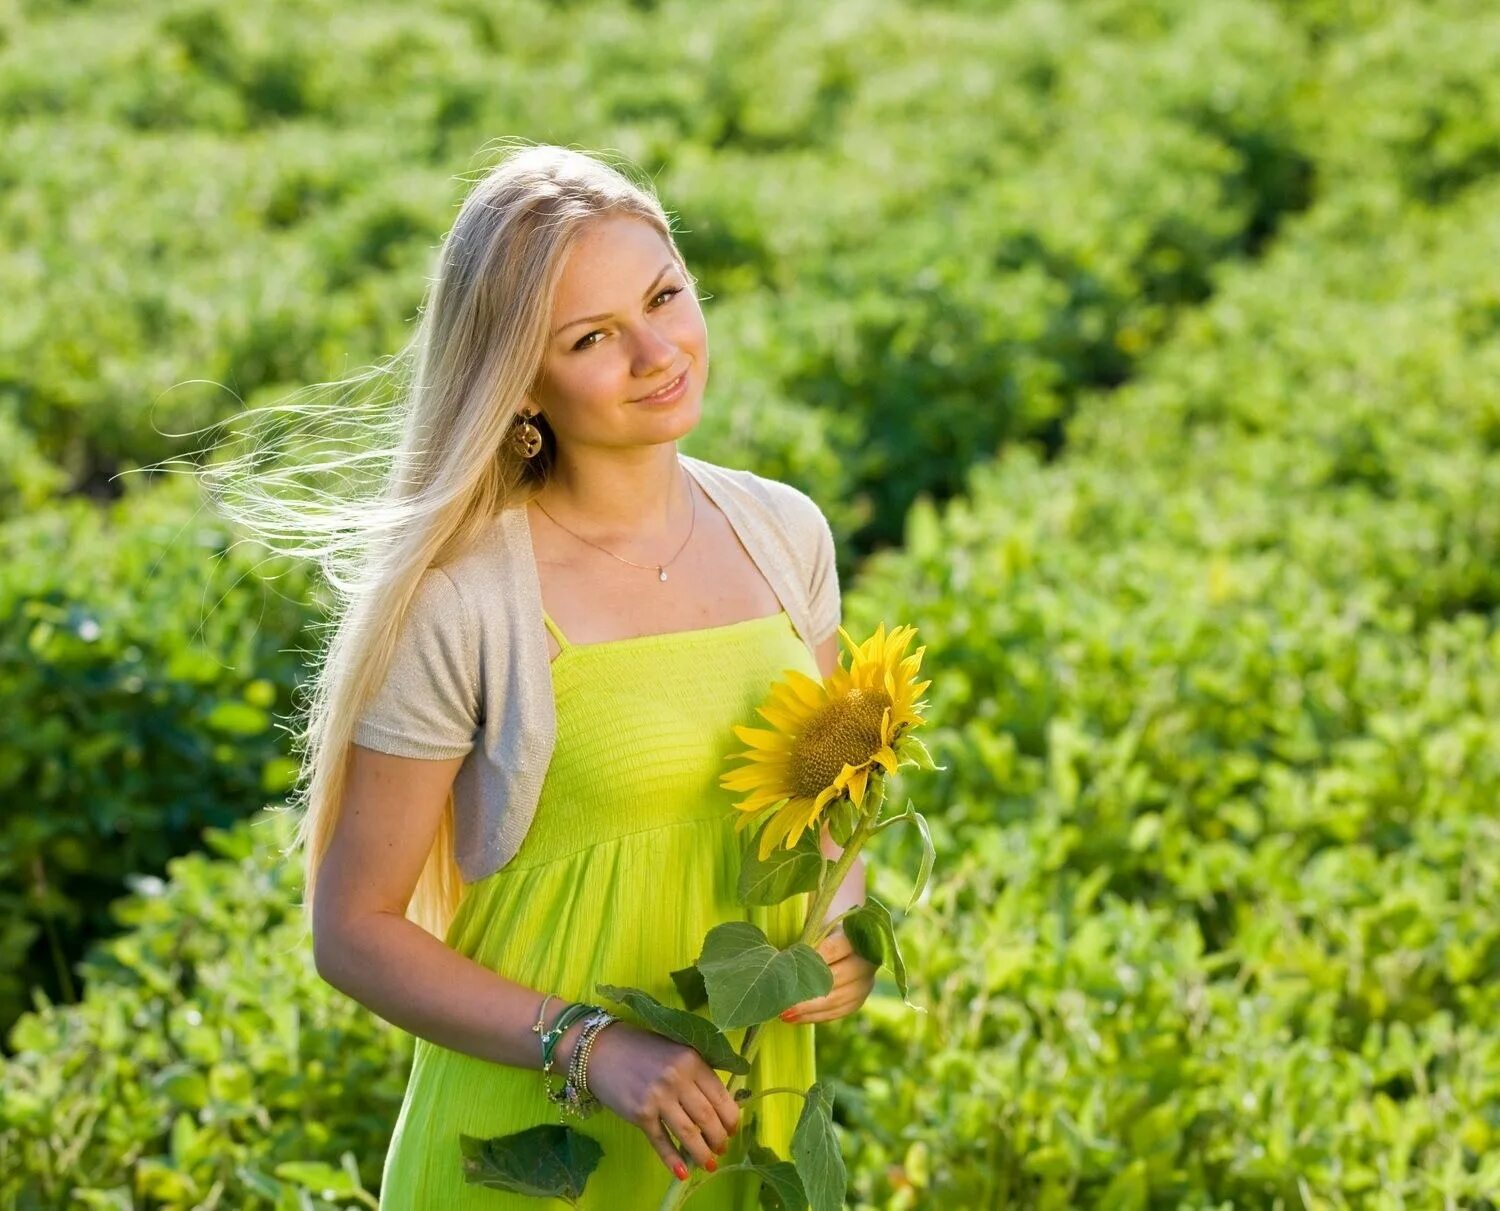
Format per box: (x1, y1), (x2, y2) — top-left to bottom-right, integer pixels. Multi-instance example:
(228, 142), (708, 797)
(314, 744), (584, 1080)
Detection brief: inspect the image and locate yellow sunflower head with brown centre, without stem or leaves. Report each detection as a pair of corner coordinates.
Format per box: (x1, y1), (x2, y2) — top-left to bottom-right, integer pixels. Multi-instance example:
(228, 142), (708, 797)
(720, 623), (932, 861)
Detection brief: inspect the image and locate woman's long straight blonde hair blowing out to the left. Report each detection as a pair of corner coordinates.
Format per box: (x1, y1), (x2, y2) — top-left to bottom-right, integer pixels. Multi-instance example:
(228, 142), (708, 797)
(201, 140), (693, 938)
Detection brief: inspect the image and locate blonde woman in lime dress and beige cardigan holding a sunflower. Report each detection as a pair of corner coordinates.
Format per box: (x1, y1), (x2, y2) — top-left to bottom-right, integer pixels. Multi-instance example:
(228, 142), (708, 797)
(246, 146), (873, 1211)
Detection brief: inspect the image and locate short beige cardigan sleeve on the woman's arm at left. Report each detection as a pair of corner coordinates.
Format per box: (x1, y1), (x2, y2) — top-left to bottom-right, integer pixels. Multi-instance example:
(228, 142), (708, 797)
(354, 567), (480, 759)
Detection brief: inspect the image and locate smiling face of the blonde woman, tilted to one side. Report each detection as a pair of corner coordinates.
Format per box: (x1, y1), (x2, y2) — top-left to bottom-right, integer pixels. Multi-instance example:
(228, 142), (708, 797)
(531, 216), (708, 447)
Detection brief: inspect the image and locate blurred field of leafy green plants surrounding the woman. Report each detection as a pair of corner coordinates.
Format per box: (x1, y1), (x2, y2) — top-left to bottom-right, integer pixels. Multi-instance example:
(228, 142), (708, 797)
(0, 0), (1500, 1211)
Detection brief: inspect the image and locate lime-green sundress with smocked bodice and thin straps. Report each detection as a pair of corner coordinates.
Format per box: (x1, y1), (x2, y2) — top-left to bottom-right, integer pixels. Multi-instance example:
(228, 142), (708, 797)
(380, 609), (821, 1211)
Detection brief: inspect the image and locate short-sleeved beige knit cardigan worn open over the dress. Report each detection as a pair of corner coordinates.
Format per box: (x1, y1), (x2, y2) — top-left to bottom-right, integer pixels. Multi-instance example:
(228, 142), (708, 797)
(354, 453), (840, 882)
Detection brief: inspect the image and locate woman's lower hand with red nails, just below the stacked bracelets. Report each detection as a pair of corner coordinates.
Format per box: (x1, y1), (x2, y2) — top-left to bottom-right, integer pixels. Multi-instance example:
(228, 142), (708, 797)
(576, 1020), (740, 1178)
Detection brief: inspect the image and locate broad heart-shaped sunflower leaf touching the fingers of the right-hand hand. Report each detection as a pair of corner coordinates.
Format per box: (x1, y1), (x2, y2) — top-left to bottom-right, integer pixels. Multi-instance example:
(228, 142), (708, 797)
(698, 921), (834, 1029)
